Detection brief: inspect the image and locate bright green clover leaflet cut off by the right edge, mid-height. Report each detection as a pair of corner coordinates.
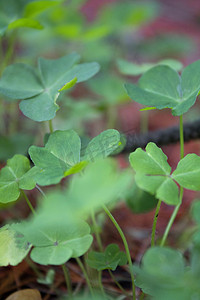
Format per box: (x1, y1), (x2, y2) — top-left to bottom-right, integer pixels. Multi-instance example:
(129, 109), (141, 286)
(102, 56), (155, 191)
(172, 153), (200, 191)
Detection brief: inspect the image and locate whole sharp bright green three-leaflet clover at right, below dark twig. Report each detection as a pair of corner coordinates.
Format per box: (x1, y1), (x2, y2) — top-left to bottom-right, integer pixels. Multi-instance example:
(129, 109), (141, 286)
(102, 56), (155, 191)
(129, 143), (200, 205)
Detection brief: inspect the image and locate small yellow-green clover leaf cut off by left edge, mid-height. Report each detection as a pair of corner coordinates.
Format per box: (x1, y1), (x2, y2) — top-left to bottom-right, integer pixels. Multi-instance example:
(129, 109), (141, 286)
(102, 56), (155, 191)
(0, 154), (36, 203)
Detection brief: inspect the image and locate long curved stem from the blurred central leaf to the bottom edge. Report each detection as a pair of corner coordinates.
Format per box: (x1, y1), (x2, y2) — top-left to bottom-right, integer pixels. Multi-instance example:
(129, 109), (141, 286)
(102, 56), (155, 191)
(103, 205), (136, 300)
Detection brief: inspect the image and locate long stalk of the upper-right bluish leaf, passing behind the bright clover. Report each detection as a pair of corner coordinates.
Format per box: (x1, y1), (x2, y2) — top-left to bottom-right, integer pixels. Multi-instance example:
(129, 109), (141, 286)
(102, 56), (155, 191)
(160, 115), (184, 246)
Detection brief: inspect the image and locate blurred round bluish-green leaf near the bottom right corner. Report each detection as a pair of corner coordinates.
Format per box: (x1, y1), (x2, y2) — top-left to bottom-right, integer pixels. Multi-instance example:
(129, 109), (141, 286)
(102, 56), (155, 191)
(133, 247), (185, 299)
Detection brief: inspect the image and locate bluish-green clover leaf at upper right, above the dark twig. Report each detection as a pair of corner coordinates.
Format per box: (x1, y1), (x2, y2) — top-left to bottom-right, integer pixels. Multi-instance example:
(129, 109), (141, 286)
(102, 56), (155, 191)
(125, 60), (200, 116)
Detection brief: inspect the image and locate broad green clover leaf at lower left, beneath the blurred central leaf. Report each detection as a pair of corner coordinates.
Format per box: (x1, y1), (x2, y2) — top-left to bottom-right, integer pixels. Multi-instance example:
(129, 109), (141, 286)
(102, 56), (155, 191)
(12, 211), (93, 265)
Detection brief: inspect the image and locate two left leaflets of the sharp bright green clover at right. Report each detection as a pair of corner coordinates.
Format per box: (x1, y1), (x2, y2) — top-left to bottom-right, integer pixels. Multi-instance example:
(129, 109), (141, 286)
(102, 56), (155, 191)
(129, 143), (179, 205)
